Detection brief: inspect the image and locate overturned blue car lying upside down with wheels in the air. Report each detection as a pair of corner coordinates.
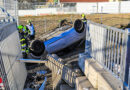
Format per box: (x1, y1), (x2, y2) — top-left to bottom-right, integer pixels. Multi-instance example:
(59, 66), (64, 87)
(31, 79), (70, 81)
(31, 19), (86, 56)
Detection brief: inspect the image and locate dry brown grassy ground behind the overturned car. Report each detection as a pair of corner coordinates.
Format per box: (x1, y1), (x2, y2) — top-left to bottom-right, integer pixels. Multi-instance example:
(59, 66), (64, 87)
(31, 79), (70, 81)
(19, 14), (130, 38)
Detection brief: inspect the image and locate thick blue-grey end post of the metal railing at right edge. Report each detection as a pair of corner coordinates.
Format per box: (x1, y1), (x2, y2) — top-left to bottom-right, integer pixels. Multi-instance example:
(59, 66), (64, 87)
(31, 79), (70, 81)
(124, 28), (130, 88)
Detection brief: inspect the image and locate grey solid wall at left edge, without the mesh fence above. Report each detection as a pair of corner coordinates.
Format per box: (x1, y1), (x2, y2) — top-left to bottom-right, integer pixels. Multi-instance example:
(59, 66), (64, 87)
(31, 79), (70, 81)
(0, 22), (27, 90)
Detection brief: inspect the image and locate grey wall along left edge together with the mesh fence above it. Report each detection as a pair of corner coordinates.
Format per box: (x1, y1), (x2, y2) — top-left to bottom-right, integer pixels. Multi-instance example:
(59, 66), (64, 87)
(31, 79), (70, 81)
(0, 0), (27, 90)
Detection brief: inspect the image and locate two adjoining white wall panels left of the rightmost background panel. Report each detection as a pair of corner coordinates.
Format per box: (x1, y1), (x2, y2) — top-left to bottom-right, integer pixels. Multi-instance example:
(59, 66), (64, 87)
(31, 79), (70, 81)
(77, 2), (120, 14)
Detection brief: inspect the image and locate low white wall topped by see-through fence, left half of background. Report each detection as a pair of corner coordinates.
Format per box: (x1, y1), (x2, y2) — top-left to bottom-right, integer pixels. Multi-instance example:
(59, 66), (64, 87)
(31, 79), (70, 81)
(18, 2), (76, 16)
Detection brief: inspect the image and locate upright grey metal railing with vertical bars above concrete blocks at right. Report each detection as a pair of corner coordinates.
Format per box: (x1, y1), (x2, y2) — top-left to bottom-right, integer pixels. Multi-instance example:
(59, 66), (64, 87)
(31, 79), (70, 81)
(86, 21), (130, 88)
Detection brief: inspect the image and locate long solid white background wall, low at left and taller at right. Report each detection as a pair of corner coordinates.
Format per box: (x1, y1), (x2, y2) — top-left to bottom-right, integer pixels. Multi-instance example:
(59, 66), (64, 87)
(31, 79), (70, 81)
(19, 1), (130, 16)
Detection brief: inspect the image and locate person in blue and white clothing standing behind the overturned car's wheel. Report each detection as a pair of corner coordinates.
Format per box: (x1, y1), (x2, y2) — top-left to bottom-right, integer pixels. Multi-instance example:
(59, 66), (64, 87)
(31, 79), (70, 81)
(26, 20), (35, 40)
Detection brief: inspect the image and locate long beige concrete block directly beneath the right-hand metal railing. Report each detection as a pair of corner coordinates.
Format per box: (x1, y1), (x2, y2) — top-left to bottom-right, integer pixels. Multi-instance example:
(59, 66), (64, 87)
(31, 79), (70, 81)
(84, 59), (122, 90)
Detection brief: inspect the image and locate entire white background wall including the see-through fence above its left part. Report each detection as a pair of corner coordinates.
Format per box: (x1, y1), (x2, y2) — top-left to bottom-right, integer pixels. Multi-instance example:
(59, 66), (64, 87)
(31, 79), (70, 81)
(19, 1), (130, 16)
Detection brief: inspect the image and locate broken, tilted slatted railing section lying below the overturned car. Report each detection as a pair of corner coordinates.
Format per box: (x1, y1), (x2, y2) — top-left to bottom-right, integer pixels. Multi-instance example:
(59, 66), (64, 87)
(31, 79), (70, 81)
(46, 54), (76, 87)
